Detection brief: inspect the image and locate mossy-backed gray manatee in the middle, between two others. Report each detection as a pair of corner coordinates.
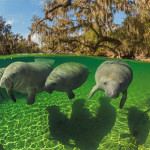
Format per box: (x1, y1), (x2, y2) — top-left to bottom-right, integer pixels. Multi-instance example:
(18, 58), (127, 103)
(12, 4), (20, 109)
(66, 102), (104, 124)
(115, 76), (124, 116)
(44, 62), (89, 99)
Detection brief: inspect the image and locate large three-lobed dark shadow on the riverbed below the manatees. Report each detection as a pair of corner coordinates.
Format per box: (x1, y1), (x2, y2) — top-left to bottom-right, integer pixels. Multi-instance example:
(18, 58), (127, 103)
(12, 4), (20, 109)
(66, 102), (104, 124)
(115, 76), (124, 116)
(47, 97), (116, 150)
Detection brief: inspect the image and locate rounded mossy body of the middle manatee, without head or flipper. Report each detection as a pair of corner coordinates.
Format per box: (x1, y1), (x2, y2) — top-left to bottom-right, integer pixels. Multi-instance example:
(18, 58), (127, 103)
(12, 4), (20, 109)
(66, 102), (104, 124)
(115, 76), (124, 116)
(48, 62), (89, 91)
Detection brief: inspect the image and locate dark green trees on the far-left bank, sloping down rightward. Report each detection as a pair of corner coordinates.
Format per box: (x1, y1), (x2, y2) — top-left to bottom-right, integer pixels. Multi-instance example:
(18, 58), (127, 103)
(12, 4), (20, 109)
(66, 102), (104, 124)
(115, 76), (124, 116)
(0, 16), (39, 55)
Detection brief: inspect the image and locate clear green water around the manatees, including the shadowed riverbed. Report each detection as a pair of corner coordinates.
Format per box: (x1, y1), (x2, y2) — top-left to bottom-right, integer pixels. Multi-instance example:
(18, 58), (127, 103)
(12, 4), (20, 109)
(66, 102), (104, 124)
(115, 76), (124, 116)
(0, 56), (150, 150)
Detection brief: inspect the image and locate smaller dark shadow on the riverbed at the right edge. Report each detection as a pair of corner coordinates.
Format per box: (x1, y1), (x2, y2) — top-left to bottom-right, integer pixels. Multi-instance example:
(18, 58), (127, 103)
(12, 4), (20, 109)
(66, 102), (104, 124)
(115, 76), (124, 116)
(121, 107), (150, 150)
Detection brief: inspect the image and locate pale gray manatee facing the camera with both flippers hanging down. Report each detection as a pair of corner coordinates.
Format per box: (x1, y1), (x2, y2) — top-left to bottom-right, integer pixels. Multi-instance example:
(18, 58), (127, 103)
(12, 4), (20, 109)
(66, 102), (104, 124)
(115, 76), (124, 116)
(89, 60), (133, 108)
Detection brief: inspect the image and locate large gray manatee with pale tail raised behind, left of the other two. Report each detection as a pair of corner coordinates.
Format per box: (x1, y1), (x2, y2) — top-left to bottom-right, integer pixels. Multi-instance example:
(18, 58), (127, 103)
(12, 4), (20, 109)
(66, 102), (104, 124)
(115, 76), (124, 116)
(0, 59), (54, 104)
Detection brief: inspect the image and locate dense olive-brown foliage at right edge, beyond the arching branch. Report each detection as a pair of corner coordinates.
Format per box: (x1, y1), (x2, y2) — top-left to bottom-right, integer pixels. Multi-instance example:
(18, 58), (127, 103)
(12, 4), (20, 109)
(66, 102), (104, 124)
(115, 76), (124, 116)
(112, 16), (150, 58)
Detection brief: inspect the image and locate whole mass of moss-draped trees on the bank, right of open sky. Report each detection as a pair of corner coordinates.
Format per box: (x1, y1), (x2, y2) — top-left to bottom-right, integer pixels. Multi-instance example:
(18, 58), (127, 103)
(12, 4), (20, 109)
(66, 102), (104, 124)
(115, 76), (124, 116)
(0, 0), (150, 59)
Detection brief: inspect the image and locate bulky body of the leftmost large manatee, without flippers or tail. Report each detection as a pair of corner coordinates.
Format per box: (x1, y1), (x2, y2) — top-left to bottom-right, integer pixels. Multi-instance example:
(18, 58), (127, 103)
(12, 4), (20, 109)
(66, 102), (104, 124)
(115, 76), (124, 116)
(2, 62), (51, 93)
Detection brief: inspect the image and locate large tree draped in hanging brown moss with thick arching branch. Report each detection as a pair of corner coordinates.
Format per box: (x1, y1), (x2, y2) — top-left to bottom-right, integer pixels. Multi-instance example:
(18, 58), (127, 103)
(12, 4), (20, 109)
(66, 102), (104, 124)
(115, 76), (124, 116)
(31, 0), (150, 56)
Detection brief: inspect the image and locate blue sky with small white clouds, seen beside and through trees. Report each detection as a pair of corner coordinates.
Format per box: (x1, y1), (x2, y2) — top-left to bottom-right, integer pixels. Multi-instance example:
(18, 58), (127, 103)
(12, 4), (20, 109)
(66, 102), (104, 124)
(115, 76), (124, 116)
(0, 0), (126, 41)
